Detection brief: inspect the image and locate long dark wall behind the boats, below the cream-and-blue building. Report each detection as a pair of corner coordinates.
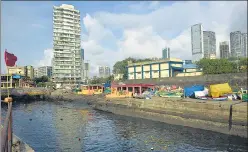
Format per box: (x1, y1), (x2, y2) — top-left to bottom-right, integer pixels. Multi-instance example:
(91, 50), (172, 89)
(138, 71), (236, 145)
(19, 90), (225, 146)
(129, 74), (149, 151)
(124, 73), (247, 88)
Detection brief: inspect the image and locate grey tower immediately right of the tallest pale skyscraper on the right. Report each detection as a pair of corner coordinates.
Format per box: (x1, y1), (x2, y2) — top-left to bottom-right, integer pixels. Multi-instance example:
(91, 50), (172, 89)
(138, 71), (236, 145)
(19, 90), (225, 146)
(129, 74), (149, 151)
(203, 31), (216, 58)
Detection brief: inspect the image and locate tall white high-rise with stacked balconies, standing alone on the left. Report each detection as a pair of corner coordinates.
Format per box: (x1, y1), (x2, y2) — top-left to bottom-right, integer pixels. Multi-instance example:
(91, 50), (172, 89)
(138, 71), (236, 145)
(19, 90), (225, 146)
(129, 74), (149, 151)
(52, 4), (82, 83)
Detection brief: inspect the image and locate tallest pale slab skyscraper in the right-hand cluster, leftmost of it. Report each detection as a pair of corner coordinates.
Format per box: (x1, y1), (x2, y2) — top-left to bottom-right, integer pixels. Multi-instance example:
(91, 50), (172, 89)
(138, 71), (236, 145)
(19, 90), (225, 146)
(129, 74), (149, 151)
(191, 24), (204, 61)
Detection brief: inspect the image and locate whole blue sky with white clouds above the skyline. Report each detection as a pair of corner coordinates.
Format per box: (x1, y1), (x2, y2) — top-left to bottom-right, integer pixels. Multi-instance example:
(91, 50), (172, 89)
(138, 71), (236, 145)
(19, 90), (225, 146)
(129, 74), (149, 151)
(1, 1), (247, 76)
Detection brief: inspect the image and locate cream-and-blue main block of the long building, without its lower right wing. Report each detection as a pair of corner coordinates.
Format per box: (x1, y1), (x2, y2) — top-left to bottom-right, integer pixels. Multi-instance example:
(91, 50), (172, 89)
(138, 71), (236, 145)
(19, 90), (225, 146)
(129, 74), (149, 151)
(127, 58), (183, 80)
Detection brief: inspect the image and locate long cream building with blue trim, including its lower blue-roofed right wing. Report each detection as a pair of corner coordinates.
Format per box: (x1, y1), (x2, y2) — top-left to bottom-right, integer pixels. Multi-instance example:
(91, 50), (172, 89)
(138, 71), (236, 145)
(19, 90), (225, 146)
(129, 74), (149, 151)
(127, 58), (202, 80)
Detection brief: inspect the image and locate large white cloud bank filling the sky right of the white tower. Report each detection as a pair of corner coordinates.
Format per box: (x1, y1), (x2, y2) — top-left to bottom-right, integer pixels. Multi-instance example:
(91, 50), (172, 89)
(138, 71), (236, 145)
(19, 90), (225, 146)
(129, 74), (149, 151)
(37, 1), (247, 75)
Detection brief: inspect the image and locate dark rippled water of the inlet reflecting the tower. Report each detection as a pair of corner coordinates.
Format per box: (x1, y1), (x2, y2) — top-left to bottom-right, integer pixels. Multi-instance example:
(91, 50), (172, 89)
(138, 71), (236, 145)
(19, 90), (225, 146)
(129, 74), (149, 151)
(2, 101), (248, 152)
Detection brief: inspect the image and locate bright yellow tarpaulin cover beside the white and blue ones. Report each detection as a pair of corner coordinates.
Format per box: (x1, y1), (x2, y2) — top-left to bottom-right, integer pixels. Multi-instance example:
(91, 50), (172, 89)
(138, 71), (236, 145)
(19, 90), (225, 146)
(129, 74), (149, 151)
(209, 83), (232, 98)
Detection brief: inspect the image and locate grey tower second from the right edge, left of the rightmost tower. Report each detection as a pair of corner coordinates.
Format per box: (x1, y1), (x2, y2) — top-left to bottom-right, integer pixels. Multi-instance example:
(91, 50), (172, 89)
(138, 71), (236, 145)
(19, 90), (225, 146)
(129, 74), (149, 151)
(230, 31), (243, 57)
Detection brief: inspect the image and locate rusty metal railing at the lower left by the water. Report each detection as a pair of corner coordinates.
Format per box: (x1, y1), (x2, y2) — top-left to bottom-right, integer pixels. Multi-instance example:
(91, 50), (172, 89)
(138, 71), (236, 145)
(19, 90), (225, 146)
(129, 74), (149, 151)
(1, 102), (13, 152)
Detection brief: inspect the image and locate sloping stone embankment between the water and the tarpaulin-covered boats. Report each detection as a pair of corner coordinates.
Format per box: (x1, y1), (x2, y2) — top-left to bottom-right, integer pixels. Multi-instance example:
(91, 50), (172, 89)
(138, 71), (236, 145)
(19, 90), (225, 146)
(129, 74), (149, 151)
(93, 97), (247, 138)
